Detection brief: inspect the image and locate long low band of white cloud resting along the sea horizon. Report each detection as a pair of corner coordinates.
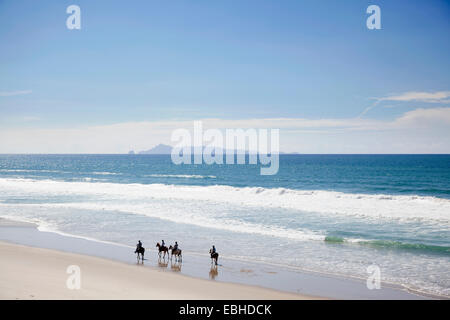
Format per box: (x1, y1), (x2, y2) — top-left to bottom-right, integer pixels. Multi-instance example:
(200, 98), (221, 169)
(0, 108), (450, 153)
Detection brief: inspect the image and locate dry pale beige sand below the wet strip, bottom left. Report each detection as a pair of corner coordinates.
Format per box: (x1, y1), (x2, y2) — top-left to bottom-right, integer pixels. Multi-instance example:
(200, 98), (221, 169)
(0, 242), (316, 299)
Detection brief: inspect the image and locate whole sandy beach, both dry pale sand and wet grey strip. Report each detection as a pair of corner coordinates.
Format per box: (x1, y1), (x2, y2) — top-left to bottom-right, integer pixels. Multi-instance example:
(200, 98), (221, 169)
(0, 219), (432, 299)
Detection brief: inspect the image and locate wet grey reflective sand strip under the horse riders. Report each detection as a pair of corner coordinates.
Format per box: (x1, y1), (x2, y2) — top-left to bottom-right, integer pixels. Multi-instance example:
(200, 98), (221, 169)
(0, 219), (438, 299)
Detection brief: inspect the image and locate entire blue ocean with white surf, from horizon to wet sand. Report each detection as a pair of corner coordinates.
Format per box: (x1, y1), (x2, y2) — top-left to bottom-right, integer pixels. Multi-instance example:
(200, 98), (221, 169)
(0, 155), (450, 297)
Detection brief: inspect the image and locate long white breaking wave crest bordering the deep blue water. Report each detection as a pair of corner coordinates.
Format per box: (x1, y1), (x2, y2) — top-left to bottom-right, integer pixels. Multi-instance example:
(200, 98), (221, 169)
(0, 178), (450, 222)
